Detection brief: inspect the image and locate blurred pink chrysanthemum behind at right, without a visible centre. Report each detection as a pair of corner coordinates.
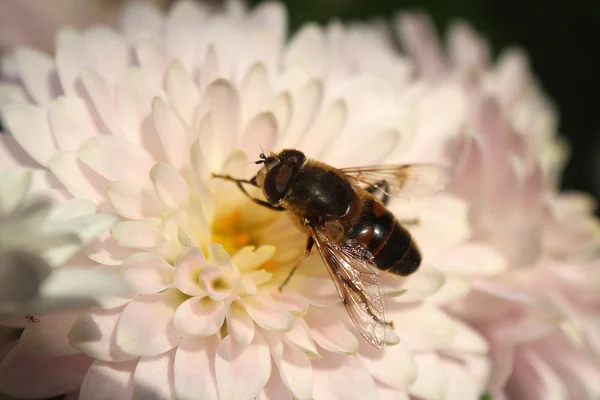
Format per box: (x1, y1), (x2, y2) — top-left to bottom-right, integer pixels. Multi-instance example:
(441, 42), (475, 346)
(330, 9), (600, 399)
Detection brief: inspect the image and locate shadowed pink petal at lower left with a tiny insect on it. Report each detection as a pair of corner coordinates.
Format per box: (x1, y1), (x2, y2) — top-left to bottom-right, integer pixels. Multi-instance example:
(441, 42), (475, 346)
(19, 312), (79, 357)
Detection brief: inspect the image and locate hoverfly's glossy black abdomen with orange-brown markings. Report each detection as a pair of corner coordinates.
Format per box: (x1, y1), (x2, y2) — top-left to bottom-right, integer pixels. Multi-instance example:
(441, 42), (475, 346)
(346, 198), (421, 275)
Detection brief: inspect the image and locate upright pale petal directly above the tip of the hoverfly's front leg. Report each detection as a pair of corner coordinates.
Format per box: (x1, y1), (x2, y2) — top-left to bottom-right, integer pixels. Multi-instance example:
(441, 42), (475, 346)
(198, 79), (240, 169)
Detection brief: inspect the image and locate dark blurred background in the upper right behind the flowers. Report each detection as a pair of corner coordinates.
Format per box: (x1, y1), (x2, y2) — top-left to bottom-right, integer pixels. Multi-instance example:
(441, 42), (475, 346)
(250, 0), (600, 209)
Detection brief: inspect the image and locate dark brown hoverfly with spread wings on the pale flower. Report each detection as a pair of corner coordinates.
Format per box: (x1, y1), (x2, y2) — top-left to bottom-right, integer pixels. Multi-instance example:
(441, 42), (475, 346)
(212, 149), (448, 348)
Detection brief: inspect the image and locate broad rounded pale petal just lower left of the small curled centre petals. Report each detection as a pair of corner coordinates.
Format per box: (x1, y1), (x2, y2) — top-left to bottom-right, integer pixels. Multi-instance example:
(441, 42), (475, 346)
(116, 290), (183, 356)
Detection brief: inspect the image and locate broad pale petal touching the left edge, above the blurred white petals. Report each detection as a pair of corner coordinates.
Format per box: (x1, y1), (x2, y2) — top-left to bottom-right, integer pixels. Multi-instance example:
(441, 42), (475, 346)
(2, 104), (56, 165)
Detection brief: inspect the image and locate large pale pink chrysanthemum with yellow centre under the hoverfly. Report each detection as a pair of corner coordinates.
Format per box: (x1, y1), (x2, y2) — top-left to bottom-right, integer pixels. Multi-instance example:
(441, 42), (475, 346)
(0, 2), (506, 400)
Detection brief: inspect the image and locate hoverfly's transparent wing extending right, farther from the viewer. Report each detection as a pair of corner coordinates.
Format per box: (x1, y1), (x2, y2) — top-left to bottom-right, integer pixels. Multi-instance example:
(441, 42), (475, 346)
(340, 164), (450, 199)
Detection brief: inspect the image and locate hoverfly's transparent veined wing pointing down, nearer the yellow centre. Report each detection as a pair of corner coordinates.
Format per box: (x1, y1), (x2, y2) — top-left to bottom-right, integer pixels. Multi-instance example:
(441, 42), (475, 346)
(312, 228), (388, 349)
